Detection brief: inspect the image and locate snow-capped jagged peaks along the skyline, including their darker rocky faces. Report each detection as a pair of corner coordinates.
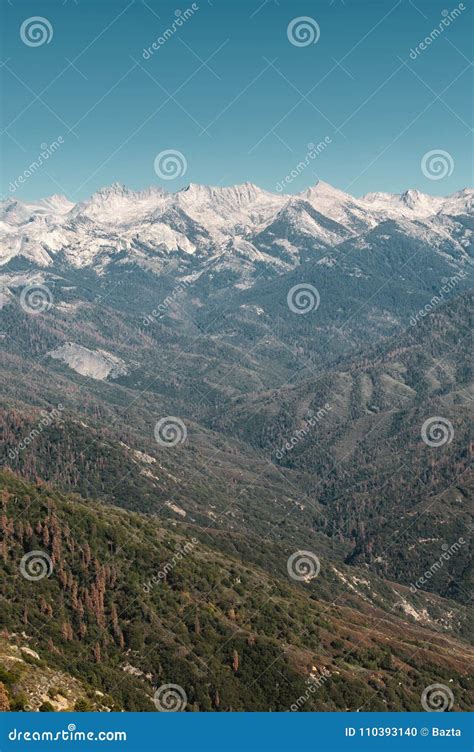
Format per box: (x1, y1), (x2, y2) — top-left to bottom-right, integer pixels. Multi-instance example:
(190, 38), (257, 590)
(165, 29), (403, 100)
(0, 182), (473, 272)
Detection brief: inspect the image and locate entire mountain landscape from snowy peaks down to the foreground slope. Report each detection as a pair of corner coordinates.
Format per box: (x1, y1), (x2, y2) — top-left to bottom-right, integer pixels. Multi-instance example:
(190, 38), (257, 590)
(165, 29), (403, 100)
(0, 182), (473, 711)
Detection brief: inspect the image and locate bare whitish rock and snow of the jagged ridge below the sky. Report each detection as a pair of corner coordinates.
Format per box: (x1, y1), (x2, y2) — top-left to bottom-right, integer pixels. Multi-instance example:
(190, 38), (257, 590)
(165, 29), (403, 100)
(0, 181), (473, 274)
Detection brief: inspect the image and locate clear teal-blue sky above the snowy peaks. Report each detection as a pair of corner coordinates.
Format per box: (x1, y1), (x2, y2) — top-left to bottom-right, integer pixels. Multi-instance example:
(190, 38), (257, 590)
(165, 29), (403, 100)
(0, 0), (472, 201)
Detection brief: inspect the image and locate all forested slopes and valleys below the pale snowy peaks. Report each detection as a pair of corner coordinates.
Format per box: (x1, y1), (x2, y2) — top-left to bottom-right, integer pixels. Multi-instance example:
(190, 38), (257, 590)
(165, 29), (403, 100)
(0, 250), (472, 712)
